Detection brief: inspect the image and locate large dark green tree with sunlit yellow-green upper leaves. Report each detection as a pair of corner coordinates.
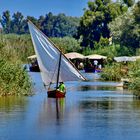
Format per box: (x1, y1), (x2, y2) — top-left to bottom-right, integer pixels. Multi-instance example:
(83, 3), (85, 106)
(77, 0), (127, 48)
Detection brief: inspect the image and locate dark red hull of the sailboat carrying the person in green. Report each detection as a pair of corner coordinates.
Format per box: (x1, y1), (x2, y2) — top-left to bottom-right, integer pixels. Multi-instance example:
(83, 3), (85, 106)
(47, 90), (65, 98)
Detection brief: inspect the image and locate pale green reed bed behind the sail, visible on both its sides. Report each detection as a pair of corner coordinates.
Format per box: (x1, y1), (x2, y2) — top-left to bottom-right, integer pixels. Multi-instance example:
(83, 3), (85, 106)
(0, 34), (81, 60)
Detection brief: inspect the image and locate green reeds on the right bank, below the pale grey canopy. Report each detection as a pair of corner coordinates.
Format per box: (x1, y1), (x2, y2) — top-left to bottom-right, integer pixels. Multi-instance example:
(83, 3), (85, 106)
(101, 60), (140, 97)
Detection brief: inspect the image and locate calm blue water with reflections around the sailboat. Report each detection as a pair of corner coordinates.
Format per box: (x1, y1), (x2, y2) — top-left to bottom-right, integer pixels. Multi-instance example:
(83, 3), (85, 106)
(0, 73), (140, 140)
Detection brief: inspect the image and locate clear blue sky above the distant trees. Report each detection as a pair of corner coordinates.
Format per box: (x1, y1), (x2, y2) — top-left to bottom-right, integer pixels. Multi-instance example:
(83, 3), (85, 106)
(0, 0), (88, 18)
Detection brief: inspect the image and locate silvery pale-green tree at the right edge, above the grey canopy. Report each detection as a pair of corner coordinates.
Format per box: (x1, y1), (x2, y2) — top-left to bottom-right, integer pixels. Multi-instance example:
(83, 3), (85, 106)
(109, 2), (140, 51)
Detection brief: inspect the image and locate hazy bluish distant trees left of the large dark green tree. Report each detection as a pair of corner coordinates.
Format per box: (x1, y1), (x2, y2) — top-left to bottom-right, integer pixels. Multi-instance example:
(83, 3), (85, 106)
(0, 10), (79, 37)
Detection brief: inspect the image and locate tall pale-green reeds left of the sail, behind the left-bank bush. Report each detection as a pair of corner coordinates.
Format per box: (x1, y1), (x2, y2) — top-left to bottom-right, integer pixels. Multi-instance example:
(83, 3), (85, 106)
(0, 34), (34, 62)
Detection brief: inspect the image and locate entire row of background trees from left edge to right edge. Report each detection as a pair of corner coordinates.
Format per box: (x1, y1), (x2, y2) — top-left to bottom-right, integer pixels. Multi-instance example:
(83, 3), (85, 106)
(0, 0), (140, 52)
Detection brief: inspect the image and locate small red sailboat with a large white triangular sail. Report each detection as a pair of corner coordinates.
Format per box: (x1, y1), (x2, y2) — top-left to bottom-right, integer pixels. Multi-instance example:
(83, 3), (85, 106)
(28, 21), (86, 98)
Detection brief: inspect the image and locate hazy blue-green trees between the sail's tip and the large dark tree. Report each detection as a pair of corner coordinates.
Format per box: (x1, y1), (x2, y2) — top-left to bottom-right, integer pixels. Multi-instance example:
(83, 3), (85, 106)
(39, 12), (79, 37)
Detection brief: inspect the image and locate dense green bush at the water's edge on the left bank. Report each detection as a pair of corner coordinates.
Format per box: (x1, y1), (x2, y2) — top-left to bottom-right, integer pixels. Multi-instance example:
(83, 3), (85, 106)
(0, 59), (31, 95)
